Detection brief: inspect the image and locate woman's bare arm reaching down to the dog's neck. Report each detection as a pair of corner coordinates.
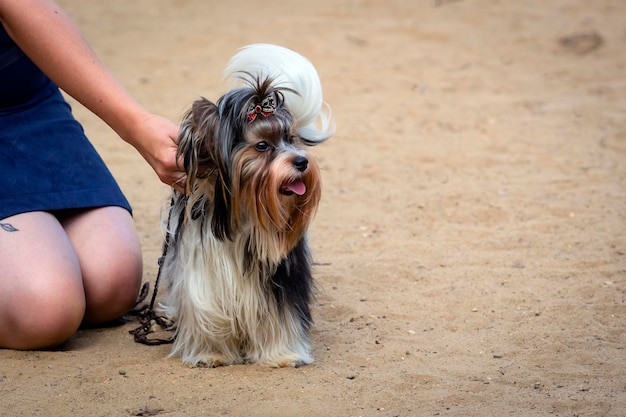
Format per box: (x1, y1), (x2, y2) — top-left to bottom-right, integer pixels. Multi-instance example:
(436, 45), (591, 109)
(0, 0), (184, 185)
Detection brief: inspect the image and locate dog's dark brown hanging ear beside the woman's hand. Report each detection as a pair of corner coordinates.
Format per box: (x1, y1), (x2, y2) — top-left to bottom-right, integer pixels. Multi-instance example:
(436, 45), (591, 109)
(178, 98), (219, 186)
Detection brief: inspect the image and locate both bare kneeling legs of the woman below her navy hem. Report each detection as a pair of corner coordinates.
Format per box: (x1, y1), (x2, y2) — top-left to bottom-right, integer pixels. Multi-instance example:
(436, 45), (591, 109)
(0, 207), (142, 349)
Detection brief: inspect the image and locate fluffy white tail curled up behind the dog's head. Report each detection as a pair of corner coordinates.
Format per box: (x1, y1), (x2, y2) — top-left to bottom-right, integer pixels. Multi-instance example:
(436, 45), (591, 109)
(224, 43), (335, 145)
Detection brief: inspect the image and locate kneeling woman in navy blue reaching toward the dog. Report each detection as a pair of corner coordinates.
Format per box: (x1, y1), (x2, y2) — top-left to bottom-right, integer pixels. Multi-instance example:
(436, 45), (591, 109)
(0, 0), (184, 349)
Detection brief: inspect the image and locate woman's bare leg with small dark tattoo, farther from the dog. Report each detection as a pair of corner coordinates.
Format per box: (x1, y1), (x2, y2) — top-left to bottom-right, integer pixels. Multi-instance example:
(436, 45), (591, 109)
(0, 212), (85, 349)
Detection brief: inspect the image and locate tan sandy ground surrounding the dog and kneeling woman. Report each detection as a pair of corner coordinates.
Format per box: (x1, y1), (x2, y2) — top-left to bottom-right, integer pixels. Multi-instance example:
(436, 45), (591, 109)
(0, 0), (626, 416)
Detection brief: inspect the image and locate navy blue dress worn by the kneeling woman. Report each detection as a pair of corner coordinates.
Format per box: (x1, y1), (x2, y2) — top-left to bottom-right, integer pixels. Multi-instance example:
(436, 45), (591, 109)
(0, 24), (131, 220)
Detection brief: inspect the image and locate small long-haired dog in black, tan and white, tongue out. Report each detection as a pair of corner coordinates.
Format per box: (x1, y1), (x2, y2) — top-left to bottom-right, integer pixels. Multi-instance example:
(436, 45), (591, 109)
(162, 44), (334, 367)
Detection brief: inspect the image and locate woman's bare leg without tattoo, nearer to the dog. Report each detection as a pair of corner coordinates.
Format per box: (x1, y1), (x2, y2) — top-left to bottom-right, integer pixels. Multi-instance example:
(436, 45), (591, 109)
(60, 207), (143, 323)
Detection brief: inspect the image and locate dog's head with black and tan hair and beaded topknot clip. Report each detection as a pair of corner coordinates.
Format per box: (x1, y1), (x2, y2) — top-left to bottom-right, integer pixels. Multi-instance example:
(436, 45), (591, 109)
(179, 79), (321, 247)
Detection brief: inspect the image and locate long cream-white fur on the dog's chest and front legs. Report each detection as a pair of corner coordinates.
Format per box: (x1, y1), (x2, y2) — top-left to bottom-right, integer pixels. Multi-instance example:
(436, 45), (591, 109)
(164, 224), (313, 367)
